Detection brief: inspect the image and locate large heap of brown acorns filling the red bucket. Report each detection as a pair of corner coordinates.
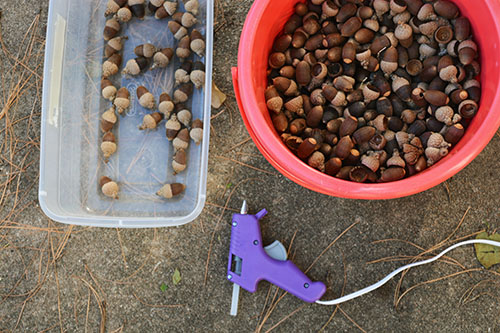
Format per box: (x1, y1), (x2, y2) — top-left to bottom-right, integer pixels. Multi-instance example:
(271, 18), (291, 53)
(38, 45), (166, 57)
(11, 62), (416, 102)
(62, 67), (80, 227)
(265, 0), (481, 182)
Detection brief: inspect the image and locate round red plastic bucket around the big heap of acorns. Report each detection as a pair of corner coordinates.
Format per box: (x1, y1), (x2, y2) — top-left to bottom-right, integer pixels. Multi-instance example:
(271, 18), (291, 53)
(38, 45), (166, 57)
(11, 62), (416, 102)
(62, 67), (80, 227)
(232, 0), (500, 199)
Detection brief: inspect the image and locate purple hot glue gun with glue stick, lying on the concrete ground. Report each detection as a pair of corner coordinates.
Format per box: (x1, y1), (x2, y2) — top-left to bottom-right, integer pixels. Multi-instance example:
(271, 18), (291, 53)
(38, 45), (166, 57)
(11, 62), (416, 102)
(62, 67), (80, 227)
(227, 201), (326, 316)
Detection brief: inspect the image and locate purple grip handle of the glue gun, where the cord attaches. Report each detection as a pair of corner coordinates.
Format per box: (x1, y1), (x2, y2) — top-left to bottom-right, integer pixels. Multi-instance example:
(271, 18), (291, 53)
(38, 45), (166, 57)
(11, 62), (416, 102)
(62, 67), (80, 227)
(263, 257), (326, 303)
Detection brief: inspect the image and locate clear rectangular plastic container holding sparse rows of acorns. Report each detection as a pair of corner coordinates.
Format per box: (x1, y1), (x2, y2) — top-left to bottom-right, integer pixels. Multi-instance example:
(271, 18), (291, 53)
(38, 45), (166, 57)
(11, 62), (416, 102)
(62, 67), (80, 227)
(39, 0), (213, 228)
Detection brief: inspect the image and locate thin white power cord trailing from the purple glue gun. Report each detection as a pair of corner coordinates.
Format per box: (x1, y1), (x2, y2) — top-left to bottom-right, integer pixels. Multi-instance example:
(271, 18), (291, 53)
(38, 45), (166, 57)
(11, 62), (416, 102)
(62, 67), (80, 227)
(316, 239), (500, 305)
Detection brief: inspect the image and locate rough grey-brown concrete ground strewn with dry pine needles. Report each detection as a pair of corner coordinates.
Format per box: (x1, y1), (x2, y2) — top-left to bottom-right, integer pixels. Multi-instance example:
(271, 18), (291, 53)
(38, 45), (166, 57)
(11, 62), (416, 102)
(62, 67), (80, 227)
(0, 0), (500, 332)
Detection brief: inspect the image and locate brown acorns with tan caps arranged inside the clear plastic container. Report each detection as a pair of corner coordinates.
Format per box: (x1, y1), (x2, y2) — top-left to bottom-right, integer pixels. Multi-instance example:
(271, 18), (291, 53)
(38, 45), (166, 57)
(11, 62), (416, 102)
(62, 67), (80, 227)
(99, 0), (205, 199)
